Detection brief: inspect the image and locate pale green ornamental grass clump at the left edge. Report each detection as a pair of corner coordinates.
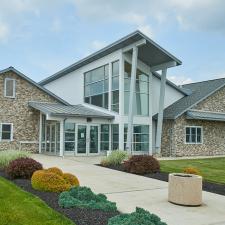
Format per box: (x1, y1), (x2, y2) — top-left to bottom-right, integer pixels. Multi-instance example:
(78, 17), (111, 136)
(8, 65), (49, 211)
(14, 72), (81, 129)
(0, 150), (30, 169)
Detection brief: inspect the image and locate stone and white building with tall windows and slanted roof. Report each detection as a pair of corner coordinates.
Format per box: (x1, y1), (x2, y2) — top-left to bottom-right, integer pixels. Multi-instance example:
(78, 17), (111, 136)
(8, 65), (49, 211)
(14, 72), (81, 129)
(0, 31), (225, 156)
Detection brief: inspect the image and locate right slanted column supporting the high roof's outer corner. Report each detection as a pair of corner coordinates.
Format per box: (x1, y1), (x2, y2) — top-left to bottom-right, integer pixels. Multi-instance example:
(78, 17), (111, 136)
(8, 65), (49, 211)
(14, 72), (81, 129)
(156, 69), (167, 154)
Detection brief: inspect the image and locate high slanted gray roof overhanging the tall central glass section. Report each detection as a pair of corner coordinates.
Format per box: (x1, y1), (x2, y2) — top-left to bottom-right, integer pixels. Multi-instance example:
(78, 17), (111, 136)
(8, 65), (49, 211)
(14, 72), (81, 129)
(39, 30), (182, 85)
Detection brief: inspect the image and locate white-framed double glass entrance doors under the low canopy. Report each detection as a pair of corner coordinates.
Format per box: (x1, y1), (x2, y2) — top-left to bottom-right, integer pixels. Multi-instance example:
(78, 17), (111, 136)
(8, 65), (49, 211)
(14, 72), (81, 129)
(77, 125), (99, 155)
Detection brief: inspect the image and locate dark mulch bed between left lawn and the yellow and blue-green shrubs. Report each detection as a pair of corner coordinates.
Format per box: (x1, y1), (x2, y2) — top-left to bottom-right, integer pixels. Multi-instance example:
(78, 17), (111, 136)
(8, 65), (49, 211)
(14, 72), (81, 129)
(0, 170), (119, 225)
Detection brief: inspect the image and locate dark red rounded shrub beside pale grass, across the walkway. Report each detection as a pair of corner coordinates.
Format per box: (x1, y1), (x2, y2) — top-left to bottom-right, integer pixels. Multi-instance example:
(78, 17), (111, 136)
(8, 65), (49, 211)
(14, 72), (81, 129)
(123, 155), (160, 174)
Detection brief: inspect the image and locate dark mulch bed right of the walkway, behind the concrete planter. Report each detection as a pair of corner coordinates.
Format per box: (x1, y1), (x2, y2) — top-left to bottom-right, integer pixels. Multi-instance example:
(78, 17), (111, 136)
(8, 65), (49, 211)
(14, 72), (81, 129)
(98, 165), (225, 195)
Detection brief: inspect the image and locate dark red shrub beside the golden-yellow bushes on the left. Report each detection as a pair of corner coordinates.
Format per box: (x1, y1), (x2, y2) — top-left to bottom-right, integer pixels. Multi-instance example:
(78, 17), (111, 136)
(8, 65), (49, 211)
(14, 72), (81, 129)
(6, 158), (43, 179)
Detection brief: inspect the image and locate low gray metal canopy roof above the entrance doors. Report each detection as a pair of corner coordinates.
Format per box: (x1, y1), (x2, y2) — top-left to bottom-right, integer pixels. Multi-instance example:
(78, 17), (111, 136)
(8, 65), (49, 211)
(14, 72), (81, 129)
(28, 101), (114, 119)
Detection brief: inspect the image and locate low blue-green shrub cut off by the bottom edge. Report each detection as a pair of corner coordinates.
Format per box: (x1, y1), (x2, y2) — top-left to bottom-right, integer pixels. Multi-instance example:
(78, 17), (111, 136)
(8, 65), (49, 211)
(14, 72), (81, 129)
(108, 207), (167, 225)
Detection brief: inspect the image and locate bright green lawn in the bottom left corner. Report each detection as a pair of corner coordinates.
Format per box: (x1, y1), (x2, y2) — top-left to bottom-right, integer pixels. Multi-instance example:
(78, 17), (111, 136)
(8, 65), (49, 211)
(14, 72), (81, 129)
(0, 177), (74, 225)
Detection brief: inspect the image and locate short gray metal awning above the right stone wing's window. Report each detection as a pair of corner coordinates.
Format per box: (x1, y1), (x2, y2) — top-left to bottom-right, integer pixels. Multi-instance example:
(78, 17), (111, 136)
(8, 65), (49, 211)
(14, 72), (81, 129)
(186, 110), (225, 121)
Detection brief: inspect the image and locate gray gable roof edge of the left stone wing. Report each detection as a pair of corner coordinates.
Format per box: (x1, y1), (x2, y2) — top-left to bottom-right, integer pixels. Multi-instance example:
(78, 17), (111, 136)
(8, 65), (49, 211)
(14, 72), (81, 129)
(0, 66), (69, 105)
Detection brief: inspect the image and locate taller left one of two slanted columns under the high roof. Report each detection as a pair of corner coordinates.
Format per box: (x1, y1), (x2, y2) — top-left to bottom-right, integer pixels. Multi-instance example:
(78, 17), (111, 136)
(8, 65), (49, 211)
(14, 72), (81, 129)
(126, 46), (138, 153)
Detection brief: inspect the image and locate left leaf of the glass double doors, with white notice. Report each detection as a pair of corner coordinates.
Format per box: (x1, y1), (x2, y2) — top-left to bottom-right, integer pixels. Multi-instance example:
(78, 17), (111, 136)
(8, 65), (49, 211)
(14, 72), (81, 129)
(77, 125), (87, 155)
